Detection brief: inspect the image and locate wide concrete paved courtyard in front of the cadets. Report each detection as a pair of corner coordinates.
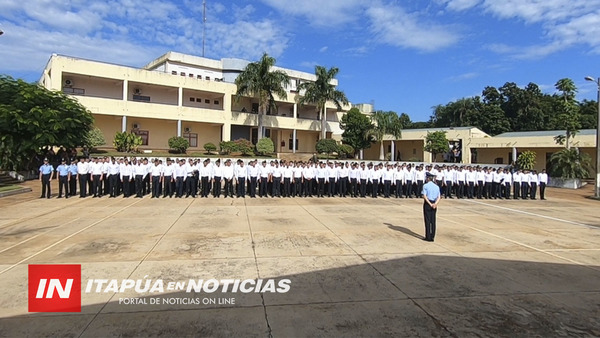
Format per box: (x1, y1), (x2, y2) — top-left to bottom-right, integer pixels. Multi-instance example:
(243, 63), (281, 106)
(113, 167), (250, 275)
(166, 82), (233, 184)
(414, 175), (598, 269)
(0, 189), (600, 337)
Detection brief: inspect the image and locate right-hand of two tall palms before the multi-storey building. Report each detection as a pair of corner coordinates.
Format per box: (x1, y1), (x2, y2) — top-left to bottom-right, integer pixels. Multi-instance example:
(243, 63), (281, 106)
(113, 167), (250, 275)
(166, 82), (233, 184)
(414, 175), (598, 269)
(298, 66), (348, 138)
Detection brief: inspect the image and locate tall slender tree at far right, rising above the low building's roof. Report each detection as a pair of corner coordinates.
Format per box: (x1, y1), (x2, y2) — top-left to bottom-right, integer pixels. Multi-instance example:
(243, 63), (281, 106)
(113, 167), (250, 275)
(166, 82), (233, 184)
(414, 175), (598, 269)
(554, 78), (581, 149)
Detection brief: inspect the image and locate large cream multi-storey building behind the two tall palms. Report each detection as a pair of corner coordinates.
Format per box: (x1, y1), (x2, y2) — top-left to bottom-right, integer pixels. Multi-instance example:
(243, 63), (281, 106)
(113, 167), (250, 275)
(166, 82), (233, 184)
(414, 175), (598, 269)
(40, 52), (350, 153)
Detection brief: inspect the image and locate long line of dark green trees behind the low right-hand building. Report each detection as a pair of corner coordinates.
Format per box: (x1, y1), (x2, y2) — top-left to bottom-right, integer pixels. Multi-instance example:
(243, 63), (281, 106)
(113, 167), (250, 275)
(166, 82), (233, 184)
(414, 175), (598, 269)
(420, 78), (597, 137)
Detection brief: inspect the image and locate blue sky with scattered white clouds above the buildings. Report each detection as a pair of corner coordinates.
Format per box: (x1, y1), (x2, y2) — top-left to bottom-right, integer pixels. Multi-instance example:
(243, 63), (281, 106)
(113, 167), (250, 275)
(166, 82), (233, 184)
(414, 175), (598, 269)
(0, 0), (600, 121)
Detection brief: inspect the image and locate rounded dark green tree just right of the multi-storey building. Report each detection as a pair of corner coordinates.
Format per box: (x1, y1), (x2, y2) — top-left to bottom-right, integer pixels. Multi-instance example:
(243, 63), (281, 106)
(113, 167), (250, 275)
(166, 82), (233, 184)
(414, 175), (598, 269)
(340, 108), (373, 158)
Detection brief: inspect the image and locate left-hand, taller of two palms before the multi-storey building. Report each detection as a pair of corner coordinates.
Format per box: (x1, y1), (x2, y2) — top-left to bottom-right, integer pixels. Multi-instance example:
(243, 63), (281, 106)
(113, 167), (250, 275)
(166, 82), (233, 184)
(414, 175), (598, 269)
(235, 53), (290, 140)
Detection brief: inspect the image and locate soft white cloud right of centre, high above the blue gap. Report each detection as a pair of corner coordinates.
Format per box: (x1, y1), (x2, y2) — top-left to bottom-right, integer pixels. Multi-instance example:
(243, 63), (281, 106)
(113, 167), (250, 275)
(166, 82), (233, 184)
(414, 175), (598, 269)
(367, 5), (459, 52)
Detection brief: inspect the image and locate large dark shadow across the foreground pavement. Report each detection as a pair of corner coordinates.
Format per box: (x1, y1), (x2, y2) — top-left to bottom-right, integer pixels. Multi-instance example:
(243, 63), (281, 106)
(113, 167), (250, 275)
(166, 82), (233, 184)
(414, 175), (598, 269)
(0, 255), (600, 337)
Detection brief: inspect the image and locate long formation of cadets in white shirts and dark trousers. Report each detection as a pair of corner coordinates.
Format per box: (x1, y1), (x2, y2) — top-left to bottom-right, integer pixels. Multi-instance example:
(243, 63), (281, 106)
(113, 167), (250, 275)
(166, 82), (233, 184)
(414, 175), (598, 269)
(40, 157), (548, 200)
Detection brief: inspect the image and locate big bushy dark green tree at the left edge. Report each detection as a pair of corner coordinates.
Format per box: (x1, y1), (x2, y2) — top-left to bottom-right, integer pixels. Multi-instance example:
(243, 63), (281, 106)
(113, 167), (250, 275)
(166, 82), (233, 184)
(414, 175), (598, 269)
(0, 75), (94, 170)
